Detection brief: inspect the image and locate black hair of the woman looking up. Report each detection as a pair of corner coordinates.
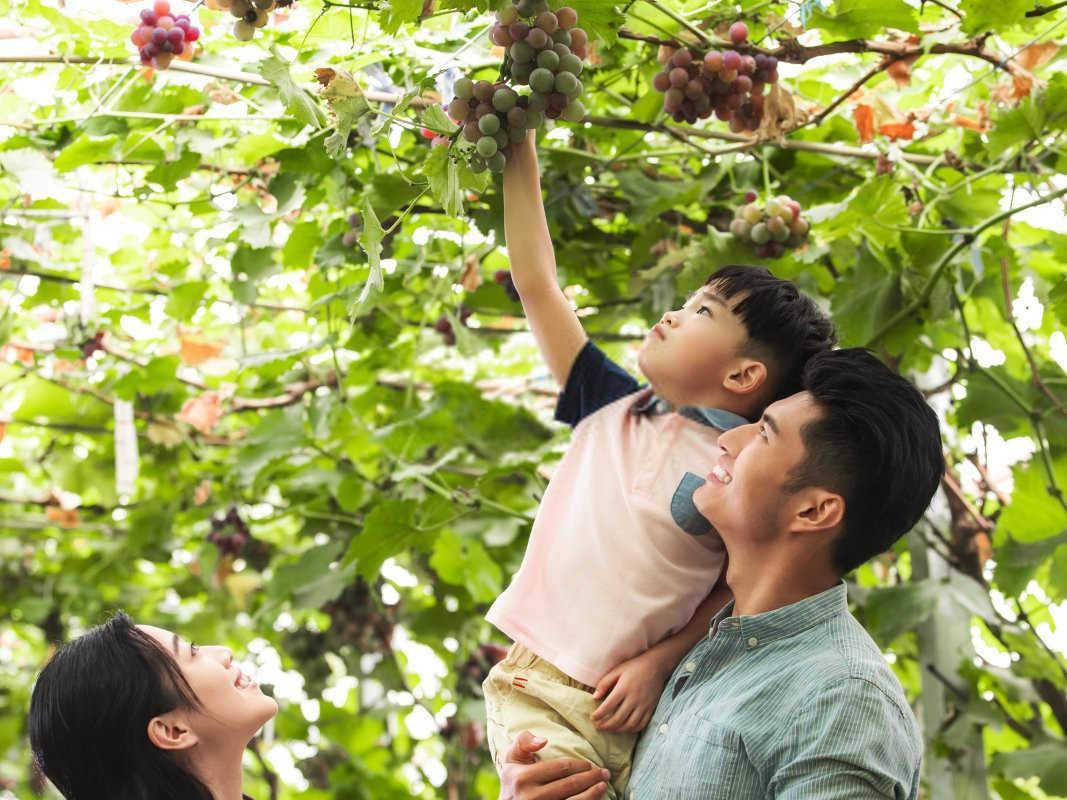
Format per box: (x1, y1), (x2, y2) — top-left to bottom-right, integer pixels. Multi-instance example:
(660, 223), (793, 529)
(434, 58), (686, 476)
(30, 611), (212, 800)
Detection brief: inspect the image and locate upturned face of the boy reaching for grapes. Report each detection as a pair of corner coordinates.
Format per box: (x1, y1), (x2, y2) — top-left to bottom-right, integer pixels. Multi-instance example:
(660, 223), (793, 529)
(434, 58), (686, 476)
(638, 285), (748, 405)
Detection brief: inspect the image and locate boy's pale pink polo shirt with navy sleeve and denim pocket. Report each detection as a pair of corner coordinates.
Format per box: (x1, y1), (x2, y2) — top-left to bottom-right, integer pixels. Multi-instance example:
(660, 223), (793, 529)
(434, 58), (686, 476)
(487, 345), (746, 686)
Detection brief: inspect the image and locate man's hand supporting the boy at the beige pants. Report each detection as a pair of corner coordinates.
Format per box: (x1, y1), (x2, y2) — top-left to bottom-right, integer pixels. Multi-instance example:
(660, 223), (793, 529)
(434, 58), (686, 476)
(499, 731), (611, 800)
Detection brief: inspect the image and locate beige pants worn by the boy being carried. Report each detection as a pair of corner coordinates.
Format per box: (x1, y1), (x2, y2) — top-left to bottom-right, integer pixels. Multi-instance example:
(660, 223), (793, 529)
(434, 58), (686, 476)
(482, 644), (637, 800)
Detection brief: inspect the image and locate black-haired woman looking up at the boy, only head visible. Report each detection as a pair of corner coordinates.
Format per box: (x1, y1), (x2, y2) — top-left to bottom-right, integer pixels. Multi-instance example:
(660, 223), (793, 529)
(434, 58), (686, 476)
(30, 611), (277, 800)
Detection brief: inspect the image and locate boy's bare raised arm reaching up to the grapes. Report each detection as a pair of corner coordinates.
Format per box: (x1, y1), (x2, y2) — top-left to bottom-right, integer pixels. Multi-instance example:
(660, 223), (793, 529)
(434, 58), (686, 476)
(504, 135), (588, 387)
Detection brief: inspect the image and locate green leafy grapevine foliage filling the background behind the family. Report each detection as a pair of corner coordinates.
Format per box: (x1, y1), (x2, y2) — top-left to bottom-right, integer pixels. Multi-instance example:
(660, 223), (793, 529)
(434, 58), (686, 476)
(0, 0), (1067, 800)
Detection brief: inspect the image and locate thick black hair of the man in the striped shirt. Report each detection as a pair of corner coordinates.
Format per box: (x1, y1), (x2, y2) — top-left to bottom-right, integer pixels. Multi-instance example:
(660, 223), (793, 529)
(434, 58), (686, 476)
(784, 348), (944, 575)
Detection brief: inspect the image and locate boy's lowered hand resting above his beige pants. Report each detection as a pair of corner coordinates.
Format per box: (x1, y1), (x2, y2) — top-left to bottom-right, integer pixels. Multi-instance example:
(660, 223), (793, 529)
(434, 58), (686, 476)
(592, 651), (670, 733)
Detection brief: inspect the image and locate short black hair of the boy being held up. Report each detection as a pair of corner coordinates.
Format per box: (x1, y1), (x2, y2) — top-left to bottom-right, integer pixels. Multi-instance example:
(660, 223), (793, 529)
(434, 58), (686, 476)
(705, 263), (838, 405)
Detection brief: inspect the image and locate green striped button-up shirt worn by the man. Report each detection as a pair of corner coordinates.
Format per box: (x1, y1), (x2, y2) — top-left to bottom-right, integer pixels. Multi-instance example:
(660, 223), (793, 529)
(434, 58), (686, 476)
(624, 582), (922, 800)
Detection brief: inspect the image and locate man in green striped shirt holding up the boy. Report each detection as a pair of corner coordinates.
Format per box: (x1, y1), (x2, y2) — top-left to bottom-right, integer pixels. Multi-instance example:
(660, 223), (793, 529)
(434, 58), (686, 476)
(501, 349), (944, 800)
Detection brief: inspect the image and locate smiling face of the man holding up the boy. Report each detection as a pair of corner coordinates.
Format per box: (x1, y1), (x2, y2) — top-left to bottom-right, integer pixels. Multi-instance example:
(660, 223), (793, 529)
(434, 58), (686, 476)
(692, 391), (819, 546)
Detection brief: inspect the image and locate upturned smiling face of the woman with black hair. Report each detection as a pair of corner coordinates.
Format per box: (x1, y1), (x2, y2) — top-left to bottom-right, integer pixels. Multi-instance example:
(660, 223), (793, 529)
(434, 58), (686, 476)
(138, 625), (277, 748)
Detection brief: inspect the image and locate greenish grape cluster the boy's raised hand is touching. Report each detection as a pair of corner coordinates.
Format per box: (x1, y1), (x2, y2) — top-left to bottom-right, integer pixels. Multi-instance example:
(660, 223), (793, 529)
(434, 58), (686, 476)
(448, 0), (589, 172)
